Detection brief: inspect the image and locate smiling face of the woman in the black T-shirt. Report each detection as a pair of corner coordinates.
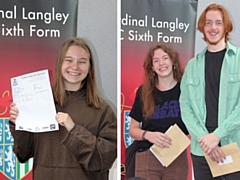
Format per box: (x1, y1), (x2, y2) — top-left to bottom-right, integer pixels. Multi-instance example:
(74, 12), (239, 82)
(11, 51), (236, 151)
(152, 49), (173, 78)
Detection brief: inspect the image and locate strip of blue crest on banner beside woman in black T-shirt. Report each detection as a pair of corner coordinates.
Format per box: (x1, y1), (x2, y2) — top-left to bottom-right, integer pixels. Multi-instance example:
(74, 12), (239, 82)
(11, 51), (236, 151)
(123, 111), (134, 147)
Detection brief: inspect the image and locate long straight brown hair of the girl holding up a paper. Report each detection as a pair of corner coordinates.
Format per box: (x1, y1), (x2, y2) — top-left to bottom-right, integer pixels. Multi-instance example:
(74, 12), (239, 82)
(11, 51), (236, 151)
(52, 38), (100, 108)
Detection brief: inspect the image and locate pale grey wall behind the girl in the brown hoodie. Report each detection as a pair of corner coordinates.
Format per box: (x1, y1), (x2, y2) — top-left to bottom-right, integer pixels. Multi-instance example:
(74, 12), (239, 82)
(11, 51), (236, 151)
(77, 0), (120, 180)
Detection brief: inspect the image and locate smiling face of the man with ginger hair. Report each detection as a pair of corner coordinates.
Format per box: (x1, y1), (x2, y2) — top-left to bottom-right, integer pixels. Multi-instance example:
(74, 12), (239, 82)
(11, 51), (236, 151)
(204, 10), (225, 46)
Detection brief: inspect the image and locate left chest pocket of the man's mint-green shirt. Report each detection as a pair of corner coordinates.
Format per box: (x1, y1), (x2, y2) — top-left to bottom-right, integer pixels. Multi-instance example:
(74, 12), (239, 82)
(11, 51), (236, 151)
(187, 78), (202, 101)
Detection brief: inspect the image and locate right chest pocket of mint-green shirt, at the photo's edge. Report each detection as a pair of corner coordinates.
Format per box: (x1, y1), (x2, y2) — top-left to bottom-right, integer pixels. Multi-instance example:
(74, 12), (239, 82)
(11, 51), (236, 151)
(227, 74), (240, 100)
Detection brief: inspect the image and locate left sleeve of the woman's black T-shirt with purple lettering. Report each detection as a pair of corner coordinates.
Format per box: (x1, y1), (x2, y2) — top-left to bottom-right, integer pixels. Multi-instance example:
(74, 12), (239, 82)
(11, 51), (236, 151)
(129, 86), (143, 122)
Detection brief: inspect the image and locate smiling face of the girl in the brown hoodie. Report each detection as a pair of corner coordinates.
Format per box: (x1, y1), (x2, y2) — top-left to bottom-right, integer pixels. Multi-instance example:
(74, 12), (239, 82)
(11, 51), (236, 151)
(61, 45), (90, 91)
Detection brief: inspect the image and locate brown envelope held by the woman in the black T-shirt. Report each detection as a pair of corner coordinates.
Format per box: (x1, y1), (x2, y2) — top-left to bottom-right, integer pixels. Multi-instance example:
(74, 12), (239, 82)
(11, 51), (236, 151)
(150, 124), (190, 167)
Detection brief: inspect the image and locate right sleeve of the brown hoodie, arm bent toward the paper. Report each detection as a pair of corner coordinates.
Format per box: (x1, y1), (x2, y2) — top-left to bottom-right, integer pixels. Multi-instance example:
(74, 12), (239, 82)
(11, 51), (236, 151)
(63, 103), (117, 172)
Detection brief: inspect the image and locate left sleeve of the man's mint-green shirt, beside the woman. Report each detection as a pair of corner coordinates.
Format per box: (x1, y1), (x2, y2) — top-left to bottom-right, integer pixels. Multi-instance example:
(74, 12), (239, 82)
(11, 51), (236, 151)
(179, 65), (208, 141)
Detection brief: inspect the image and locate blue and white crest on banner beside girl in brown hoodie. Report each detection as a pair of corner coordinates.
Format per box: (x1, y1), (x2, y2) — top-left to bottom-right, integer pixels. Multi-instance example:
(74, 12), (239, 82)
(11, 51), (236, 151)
(0, 118), (32, 179)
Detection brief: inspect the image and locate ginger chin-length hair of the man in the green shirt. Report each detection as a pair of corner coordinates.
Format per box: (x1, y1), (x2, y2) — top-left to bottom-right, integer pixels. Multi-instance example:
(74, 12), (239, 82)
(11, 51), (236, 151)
(197, 4), (233, 41)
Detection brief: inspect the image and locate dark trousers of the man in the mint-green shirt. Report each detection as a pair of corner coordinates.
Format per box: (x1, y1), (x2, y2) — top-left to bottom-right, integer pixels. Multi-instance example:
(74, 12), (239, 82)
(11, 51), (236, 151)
(191, 154), (240, 180)
